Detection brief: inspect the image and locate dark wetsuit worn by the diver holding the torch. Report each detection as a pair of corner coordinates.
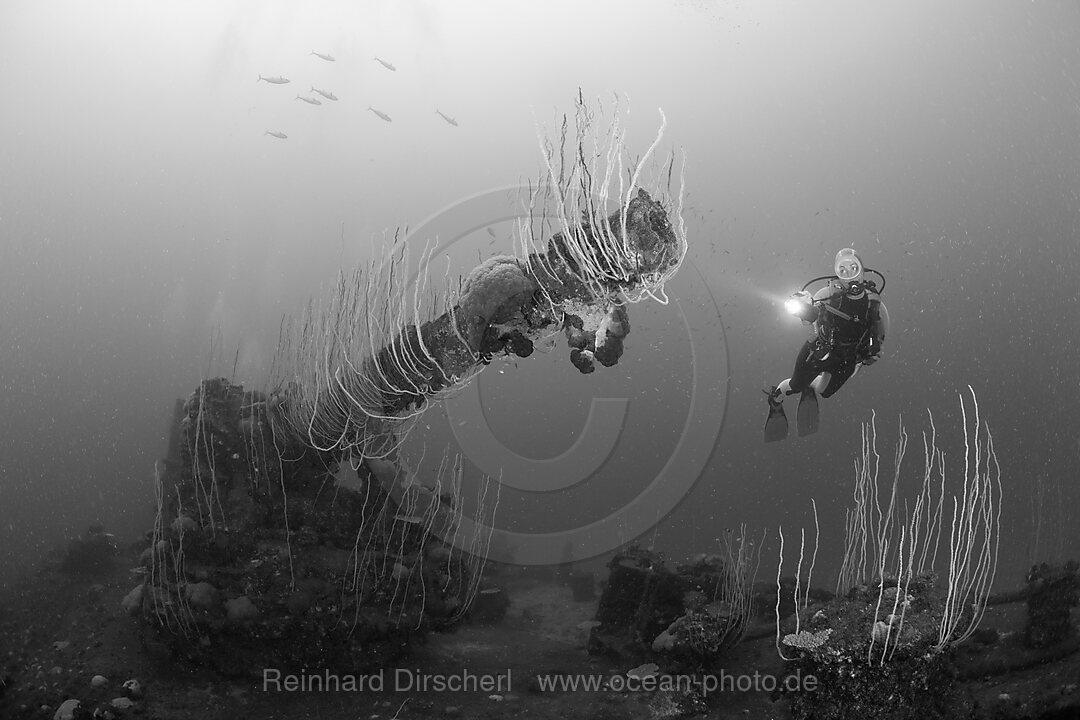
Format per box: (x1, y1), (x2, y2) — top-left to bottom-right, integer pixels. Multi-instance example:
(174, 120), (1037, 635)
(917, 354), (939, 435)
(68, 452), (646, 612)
(788, 282), (883, 397)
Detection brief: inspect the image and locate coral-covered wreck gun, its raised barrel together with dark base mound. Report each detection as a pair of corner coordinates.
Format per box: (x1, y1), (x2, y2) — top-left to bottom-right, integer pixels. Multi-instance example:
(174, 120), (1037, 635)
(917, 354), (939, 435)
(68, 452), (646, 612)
(125, 97), (686, 675)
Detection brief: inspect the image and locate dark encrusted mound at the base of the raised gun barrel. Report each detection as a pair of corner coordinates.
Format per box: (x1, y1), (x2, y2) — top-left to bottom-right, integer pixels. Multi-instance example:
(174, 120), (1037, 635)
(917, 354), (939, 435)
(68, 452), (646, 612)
(124, 379), (494, 676)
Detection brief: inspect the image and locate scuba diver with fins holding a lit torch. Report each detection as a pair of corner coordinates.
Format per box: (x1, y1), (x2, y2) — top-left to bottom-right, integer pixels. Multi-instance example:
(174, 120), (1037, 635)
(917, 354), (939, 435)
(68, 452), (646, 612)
(765, 247), (889, 443)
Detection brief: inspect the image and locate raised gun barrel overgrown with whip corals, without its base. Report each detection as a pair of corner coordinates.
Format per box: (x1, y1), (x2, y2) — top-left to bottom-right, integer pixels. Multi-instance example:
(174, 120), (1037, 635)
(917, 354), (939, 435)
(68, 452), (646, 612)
(273, 92), (687, 457)
